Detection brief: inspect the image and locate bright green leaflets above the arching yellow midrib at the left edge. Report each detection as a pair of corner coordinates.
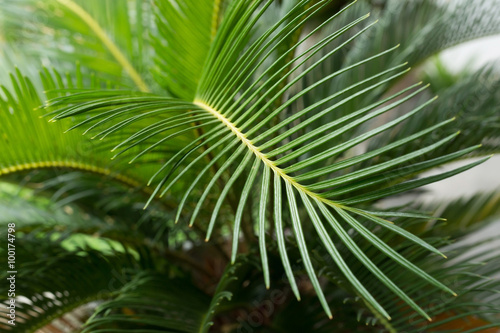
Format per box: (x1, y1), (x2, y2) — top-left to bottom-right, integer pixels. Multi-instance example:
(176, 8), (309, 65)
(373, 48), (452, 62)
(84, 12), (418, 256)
(0, 70), (170, 192)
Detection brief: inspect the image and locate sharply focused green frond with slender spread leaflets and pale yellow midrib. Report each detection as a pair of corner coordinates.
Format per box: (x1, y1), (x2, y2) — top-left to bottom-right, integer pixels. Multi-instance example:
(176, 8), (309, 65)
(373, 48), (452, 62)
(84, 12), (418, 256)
(43, 1), (492, 318)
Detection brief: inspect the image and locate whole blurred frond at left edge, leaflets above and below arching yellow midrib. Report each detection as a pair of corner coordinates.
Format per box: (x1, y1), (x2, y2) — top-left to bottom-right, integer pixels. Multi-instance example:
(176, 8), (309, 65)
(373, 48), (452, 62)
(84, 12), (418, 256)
(0, 68), (197, 243)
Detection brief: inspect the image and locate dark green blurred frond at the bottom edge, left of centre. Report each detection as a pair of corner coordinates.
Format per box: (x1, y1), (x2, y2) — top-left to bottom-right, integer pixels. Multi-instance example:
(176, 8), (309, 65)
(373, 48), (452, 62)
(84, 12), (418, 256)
(83, 255), (250, 333)
